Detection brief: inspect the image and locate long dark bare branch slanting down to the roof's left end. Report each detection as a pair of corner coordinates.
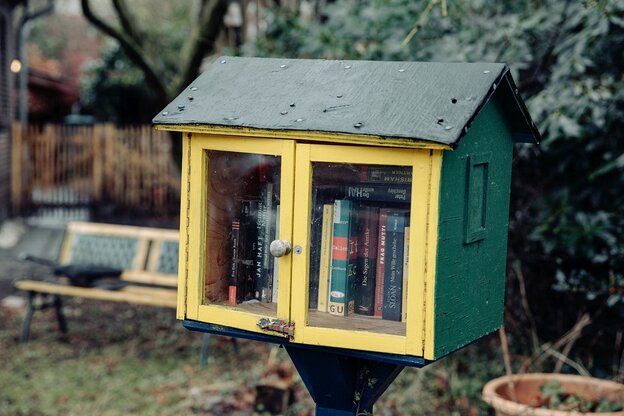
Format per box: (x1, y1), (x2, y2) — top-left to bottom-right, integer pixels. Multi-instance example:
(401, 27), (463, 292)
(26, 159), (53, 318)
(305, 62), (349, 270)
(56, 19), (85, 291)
(80, 0), (169, 103)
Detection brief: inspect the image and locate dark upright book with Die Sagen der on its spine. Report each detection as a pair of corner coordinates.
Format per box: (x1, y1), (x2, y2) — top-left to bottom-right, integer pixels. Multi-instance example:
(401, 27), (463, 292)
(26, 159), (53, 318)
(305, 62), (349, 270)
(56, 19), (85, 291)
(355, 206), (379, 316)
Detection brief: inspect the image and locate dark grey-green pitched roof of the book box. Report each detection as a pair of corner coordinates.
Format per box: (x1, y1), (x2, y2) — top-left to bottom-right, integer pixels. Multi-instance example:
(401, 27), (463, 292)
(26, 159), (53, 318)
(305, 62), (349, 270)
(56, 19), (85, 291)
(153, 57), (540, 146)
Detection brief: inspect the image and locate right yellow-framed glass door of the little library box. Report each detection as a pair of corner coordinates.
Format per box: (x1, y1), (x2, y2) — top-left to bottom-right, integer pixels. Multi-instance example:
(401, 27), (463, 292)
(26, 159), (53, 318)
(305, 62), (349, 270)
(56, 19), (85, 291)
(293, 145), (429, 353)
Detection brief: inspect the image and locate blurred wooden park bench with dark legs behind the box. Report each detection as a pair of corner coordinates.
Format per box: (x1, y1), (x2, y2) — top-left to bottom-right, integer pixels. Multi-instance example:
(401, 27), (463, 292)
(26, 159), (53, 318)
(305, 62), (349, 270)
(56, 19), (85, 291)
(15, 222), (179, 342)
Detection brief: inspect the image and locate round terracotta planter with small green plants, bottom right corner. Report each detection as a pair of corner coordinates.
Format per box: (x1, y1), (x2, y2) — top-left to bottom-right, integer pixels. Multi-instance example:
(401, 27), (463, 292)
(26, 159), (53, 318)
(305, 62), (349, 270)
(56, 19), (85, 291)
(483, 373), (624, 416)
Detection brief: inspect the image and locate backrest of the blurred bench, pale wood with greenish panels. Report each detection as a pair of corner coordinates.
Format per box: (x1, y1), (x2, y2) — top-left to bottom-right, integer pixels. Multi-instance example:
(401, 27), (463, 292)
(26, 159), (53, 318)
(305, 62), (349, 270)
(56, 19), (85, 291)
(58, 222), (179, 284)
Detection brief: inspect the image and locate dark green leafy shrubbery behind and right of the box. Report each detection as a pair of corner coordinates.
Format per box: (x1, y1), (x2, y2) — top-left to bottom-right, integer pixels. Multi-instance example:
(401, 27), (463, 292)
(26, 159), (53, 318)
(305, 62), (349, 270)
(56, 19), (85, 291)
(245, 0), (624, 372)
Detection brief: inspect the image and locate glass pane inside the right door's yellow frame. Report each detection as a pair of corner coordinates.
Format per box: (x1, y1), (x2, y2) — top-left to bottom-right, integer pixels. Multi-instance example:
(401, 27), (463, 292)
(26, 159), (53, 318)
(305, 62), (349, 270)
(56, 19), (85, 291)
(308, 163), (412, 335)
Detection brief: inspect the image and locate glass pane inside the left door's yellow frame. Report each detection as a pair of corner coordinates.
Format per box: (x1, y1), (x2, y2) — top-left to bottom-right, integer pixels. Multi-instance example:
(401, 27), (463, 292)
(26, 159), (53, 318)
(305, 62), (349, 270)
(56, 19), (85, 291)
(205, 150), (281, 314)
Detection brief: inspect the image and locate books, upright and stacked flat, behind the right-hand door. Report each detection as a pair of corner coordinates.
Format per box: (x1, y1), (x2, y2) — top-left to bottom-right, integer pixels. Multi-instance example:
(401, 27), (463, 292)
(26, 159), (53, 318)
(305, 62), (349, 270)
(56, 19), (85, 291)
(310, 166), (411, 321)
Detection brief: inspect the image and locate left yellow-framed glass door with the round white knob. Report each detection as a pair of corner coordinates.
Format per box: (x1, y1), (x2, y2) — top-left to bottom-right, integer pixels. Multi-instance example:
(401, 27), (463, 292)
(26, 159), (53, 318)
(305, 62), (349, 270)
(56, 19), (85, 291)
(189, 137), (294, 331)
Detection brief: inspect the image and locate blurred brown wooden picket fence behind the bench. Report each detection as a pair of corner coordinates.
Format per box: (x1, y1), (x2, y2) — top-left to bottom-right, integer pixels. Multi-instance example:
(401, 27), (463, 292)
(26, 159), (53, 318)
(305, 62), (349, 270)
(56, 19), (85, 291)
(11, 124), (180, 217)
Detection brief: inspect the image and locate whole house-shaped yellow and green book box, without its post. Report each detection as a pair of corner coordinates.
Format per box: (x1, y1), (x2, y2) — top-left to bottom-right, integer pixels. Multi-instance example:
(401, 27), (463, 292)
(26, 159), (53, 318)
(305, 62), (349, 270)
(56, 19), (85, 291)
(154, 57), (539, 360)
